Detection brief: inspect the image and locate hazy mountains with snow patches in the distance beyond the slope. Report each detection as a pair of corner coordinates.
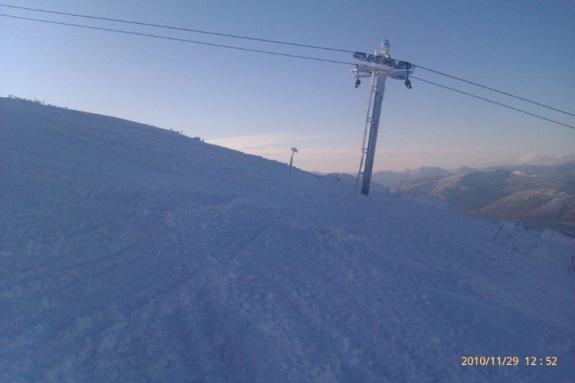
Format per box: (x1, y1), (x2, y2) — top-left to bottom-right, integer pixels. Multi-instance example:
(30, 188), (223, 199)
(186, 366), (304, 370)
(373, 161), (575, 236)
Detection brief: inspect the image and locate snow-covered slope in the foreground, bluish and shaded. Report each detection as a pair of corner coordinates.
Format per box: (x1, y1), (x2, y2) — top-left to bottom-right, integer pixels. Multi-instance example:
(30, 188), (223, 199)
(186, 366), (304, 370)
(0, 99), (575, 382)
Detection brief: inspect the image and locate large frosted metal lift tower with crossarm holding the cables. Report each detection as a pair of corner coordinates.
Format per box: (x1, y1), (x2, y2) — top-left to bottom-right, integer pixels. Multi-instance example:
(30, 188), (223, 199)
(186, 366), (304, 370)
(353, 40), (413, 196)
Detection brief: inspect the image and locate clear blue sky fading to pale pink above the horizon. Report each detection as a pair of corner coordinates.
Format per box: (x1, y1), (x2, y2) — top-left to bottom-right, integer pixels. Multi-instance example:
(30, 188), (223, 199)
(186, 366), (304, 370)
(0, 0), (575, 172)
